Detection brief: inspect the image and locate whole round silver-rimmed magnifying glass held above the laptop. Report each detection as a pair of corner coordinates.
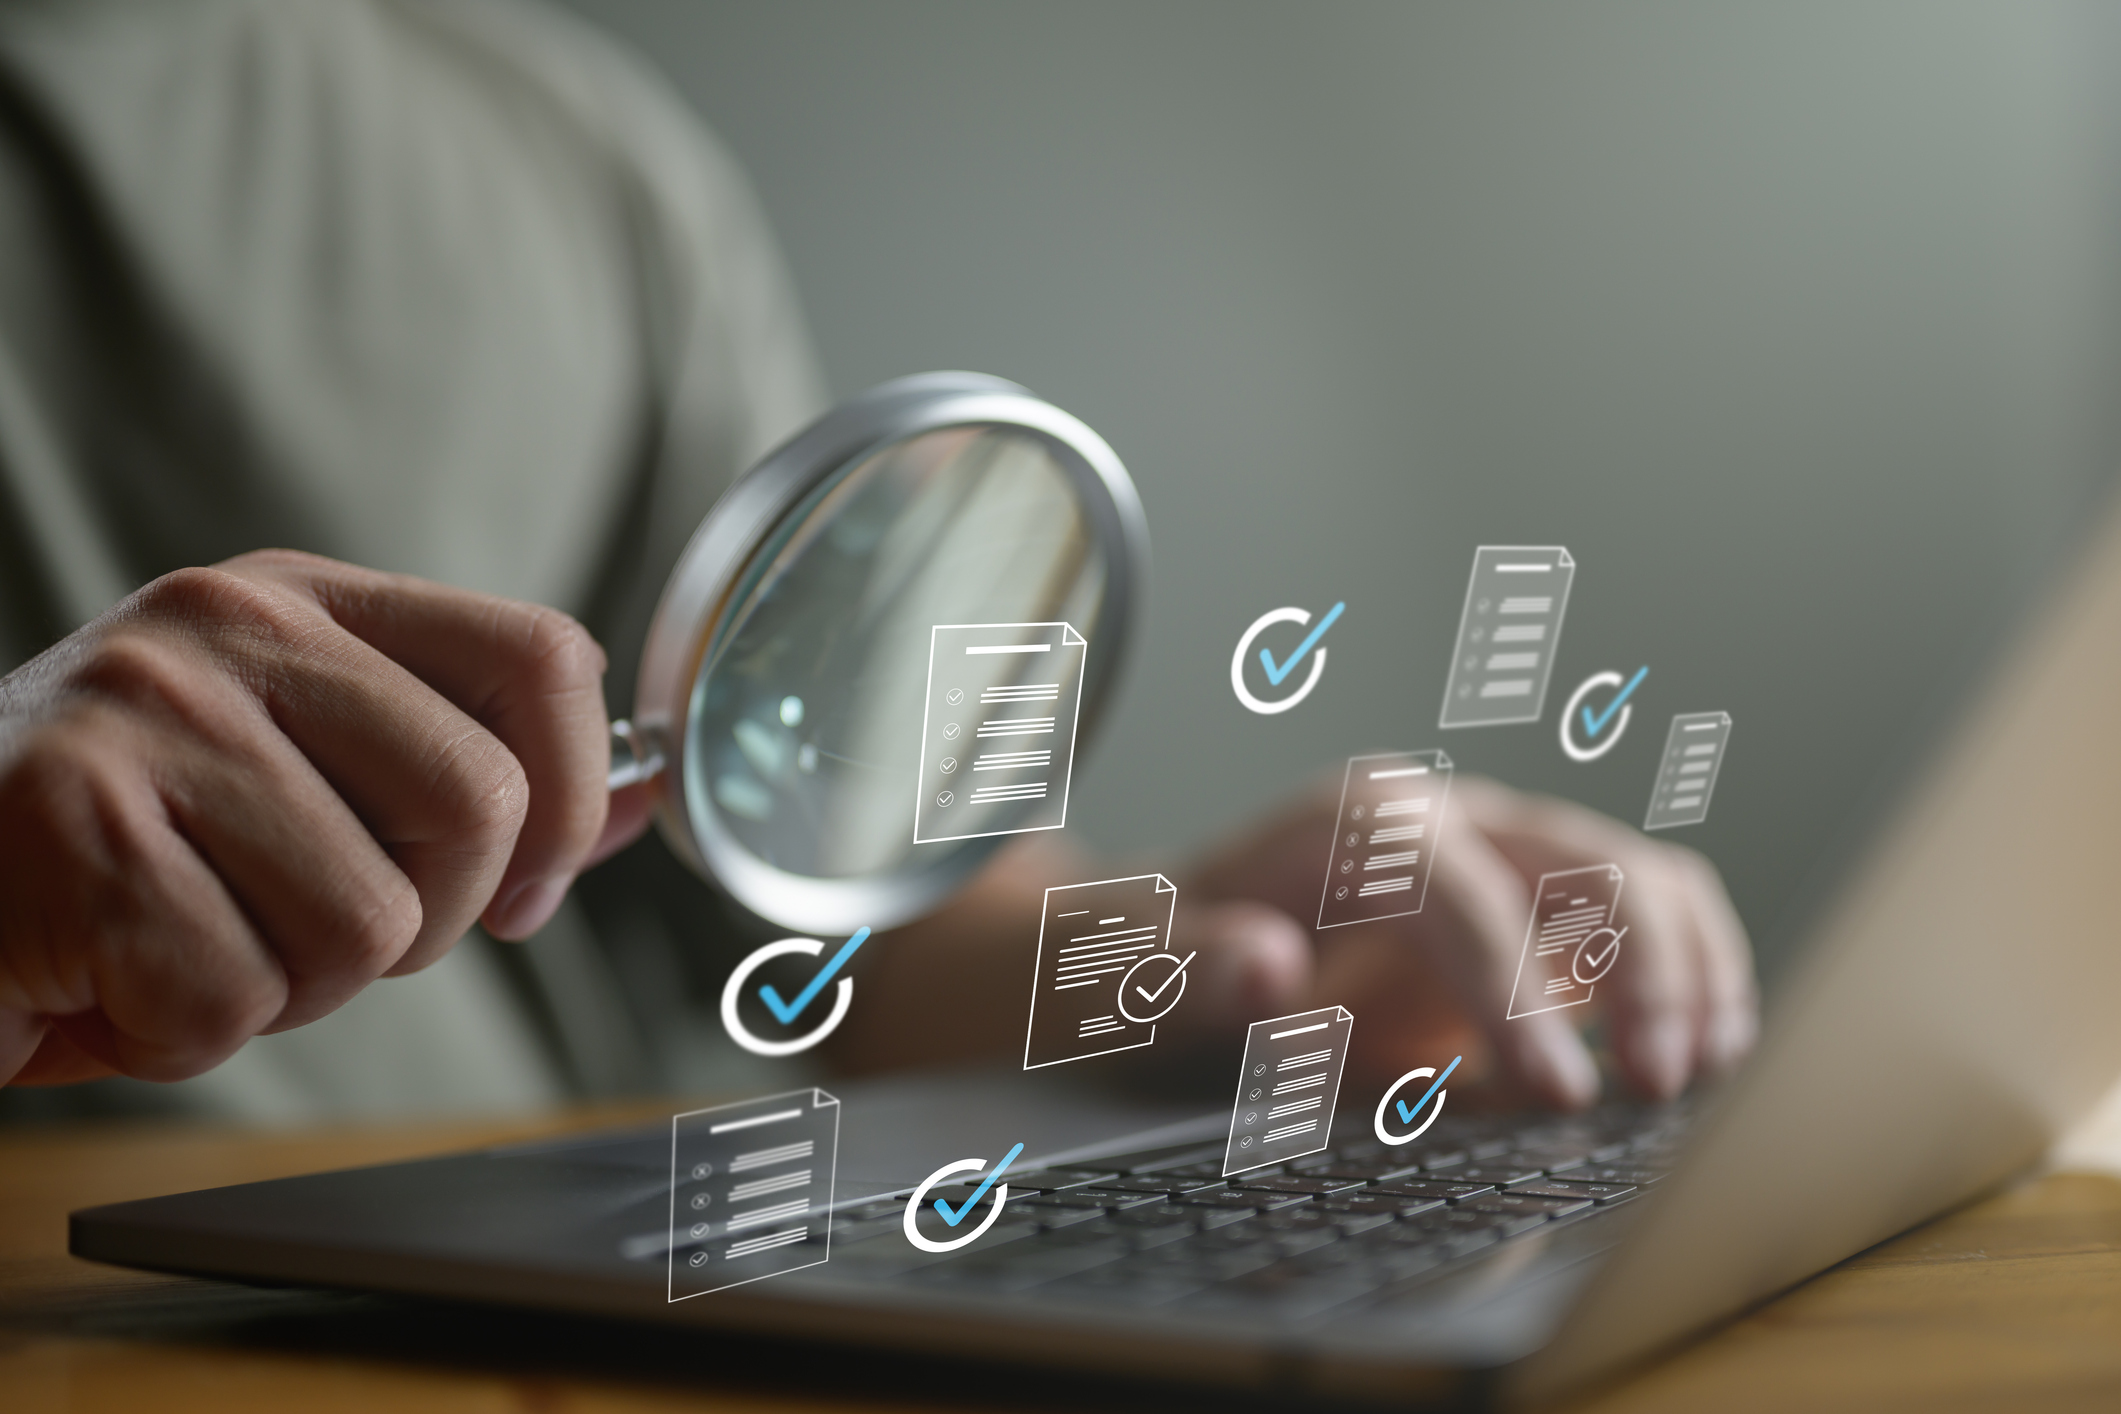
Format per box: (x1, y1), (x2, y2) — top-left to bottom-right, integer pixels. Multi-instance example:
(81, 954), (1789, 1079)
(611, 373), (1147, 935)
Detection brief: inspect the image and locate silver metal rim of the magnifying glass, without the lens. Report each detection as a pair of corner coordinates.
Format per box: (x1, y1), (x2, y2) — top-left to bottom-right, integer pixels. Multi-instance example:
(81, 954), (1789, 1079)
(611, 373), (1150, 933)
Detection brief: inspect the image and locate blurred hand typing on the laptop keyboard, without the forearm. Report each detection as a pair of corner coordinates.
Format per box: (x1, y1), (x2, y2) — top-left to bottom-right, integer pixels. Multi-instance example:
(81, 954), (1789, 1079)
(1173, 776), (1758, 1109)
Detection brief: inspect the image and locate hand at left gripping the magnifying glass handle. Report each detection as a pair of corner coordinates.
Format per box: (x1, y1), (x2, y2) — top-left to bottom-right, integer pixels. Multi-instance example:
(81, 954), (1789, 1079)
(0, 551), (649, 1083)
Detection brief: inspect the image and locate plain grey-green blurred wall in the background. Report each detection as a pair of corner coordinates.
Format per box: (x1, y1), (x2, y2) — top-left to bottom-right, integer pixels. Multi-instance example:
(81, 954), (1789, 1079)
(577, 0), (2121, 992)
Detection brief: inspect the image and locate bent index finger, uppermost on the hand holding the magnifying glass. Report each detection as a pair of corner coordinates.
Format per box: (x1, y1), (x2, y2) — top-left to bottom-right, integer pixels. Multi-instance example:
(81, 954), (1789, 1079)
(231, 553), (611, 937)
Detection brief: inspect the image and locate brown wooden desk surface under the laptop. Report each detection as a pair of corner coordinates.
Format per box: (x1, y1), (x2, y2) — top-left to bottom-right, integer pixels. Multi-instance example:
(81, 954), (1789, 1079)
(0, 1111), (2121, 1414)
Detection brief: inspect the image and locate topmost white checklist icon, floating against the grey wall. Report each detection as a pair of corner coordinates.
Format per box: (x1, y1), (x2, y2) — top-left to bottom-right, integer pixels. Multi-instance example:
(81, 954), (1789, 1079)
(1438, 545), (1576, 727)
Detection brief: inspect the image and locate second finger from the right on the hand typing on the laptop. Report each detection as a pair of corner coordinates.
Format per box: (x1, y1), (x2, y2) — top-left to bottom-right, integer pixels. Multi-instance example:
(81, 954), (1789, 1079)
(1463, 782), (1703, 1098)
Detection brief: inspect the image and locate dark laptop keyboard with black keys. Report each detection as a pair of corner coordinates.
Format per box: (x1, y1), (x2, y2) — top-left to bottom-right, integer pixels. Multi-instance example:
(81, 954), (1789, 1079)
(797, 1104), (1686, 1316)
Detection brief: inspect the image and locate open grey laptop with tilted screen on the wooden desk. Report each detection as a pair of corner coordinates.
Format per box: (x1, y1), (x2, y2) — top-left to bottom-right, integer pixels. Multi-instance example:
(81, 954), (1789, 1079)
(70, 487), (2121, 1403)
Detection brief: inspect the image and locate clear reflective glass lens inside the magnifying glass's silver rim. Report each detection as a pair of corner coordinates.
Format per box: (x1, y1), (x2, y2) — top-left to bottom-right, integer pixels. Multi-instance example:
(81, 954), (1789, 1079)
(685, 426), (1107, 878)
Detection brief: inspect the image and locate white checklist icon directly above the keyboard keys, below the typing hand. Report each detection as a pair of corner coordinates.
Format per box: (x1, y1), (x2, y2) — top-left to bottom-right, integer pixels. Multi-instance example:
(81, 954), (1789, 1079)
(1222, 1007), (1355, 1177)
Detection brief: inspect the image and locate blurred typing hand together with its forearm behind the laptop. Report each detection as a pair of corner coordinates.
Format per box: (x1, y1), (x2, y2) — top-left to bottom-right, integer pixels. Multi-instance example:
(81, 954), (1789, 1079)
(836, 776), (1758, 1109)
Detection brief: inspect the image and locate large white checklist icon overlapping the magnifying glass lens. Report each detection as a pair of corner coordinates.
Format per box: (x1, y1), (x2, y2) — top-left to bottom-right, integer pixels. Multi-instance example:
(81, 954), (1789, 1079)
(914, 623), (1090, 844)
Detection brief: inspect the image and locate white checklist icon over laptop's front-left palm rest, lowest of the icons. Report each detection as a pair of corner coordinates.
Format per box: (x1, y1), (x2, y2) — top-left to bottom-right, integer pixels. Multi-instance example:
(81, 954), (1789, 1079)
(668, 1090), (840, 1302)
